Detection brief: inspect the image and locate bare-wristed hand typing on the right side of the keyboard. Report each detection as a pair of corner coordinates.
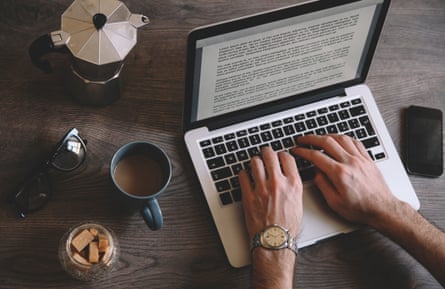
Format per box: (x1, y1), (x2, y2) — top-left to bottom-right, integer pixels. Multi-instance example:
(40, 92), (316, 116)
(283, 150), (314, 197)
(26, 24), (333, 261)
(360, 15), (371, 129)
(292, 135), (398, 225)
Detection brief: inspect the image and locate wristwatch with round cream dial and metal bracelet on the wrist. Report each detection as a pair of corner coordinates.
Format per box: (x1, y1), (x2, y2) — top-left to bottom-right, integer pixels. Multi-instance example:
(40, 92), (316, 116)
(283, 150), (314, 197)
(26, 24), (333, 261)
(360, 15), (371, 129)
(252, 224), (298, 255)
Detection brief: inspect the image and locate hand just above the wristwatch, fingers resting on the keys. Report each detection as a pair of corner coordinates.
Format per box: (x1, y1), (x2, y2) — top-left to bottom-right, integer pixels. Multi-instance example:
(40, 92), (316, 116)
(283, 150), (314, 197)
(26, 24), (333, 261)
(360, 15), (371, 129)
(239, 147), (303, 238)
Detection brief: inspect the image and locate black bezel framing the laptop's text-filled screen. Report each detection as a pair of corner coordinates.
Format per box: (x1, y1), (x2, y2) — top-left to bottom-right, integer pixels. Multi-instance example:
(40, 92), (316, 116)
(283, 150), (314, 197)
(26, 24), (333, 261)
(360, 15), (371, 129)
(183, 0), (390, 131)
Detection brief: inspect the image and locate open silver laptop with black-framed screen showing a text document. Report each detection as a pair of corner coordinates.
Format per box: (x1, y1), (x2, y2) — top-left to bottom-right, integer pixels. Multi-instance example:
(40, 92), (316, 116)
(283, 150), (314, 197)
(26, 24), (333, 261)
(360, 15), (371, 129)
(183, 0), (420, 267)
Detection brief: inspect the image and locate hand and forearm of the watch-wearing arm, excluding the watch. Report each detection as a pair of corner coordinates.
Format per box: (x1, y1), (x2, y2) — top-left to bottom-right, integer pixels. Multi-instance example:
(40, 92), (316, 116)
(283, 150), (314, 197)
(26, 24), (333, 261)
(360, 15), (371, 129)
(239, 147), (303, 289)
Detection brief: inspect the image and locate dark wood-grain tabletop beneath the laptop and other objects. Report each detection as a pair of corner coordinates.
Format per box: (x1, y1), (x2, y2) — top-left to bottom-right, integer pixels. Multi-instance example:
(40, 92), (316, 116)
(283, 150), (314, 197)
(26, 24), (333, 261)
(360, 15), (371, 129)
(0, 0), (445, 289)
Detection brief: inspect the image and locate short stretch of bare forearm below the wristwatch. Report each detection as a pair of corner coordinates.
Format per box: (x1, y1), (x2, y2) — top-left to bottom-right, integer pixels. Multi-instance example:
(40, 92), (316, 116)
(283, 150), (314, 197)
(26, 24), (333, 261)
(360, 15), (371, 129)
(252, 247), (296, 289)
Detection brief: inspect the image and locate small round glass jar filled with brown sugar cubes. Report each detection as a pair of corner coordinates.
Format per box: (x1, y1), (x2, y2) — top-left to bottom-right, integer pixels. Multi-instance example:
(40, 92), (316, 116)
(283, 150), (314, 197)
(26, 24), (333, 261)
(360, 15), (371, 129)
(59, 222), (119, 281)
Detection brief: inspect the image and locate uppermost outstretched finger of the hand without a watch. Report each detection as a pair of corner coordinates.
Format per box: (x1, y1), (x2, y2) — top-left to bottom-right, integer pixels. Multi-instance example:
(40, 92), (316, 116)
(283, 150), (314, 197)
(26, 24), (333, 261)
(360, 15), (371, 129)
(297, 135), (349, 162)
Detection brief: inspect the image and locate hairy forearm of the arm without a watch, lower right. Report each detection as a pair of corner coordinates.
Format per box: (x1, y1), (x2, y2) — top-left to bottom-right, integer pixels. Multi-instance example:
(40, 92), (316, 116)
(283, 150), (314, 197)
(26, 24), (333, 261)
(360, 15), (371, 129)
(373, 202), (445, 287)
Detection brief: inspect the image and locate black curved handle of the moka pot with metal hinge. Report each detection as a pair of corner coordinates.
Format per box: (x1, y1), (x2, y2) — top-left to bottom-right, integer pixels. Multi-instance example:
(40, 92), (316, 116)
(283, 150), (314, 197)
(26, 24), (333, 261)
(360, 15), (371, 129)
(29, 31), (69, 73)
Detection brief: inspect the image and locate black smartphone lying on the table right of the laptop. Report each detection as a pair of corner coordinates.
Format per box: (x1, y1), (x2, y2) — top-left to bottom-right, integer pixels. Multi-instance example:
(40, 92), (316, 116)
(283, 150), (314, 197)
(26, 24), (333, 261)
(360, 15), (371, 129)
(405, 106), (443, 177)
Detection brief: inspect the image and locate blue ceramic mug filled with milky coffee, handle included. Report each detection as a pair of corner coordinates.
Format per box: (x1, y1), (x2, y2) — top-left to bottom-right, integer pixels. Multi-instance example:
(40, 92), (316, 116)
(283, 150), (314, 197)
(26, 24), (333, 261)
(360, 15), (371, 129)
(110, 141), (172, 230)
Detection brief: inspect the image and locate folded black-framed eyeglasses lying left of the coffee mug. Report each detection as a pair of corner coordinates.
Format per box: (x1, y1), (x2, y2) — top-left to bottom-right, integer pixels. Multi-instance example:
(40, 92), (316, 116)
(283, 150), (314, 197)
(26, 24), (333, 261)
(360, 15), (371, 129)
(14, 128), (87, 218)
